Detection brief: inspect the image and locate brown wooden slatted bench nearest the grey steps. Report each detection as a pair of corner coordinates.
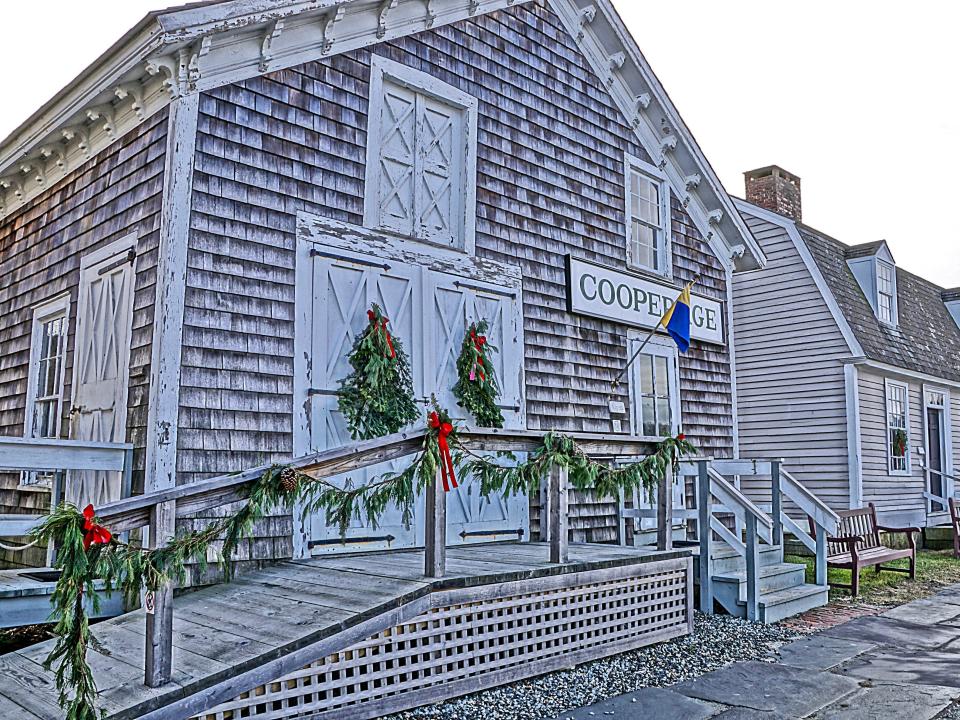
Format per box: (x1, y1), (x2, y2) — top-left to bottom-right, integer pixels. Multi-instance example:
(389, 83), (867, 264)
(811, 503), (920, 597)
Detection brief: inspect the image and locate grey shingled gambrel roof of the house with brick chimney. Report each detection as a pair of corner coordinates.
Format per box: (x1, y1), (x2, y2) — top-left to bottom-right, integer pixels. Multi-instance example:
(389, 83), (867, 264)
(797, 223), (960, 381)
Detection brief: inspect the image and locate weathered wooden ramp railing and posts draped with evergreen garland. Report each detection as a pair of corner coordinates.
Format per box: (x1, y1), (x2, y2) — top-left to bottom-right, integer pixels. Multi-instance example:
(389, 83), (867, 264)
(77, 429), (655, 687)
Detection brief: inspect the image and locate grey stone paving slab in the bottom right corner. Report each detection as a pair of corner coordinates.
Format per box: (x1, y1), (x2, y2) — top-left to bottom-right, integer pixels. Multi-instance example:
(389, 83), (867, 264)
(810, 683), (958, 720)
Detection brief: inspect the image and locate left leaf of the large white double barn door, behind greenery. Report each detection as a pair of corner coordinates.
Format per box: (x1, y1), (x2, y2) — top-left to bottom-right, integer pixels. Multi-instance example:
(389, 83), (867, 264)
(308, 254), (422, 553)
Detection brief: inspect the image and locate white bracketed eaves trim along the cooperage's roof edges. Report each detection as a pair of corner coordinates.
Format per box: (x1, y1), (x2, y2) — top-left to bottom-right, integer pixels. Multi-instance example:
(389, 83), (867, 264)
(0, 0), (765, 269)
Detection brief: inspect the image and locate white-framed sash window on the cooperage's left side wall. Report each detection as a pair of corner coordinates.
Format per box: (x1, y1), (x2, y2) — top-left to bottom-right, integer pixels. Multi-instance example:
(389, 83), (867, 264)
(20, 295), (70, 486)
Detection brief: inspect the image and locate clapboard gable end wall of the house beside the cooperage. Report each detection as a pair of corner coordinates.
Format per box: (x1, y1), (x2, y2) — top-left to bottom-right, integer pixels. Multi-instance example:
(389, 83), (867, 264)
(733, 215), (850, 510)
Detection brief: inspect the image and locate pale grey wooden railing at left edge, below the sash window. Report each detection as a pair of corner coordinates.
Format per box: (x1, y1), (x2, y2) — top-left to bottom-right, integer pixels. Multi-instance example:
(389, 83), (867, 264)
(0, 437), (133, 537)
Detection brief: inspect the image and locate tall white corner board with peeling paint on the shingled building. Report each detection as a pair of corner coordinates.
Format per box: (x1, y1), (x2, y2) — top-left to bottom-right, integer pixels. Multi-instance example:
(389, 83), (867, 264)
(144, 93), (199, 491)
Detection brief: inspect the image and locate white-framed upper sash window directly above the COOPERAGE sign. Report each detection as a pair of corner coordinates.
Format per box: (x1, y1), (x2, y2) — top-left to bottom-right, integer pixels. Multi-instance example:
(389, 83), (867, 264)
(624, 153), (671, 277)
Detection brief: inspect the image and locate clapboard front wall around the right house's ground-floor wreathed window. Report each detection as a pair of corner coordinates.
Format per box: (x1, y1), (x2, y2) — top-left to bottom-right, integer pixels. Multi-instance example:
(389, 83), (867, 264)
(859, 368), (926, 525)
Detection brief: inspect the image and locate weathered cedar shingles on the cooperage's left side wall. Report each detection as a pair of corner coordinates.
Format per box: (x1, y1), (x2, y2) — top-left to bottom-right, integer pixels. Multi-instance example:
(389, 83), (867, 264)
(0, 110), (167, 564)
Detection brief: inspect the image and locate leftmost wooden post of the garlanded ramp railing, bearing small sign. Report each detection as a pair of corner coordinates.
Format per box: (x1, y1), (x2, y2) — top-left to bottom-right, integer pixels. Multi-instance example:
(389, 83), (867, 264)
(143, 500), (177, 687)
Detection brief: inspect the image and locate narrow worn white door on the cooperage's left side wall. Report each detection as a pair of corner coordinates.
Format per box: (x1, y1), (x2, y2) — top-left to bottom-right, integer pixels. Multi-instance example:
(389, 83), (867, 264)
(64, 237), (136, 508)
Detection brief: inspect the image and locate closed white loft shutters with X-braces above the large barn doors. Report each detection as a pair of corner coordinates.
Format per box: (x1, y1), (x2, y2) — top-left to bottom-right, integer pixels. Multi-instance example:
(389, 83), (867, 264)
(364, 55), (477, 253)
